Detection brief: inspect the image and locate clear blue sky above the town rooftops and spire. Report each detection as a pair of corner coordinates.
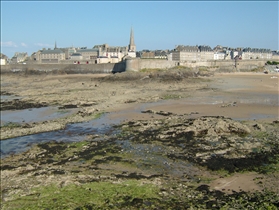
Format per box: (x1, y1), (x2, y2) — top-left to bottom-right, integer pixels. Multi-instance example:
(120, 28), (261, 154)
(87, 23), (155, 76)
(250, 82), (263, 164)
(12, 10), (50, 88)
(1, 1), (279, 57)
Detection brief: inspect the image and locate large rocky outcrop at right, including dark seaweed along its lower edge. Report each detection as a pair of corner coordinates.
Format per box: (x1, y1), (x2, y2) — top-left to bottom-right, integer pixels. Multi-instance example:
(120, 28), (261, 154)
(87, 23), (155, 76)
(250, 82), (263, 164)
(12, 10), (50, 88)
(119, 115), (278, 171)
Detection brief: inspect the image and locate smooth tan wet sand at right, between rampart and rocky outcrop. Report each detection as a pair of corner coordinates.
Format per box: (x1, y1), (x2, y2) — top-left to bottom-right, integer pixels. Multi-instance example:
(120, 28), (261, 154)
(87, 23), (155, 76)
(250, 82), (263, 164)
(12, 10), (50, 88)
(108, 73), (279, 122)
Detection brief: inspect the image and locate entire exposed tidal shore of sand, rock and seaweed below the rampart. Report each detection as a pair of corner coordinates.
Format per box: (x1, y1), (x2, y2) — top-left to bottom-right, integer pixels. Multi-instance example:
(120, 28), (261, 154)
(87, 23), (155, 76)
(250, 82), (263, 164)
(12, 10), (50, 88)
(1, 69), (279, 209)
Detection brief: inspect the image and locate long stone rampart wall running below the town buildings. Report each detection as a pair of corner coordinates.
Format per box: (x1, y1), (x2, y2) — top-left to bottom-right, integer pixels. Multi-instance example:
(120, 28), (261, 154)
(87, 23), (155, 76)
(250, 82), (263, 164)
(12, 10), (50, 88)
(1, 58), (276, 74)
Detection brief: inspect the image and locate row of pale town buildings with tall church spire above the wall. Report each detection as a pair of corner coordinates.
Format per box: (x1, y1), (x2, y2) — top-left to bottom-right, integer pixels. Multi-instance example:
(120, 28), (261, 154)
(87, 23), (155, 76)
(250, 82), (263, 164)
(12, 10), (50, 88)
(1, 29), (279, 65)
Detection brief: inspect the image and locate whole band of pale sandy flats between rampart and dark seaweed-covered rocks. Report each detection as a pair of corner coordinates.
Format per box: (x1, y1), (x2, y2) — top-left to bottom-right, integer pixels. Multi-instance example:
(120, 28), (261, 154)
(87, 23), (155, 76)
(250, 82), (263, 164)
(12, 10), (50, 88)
(1, 73), (279, 139)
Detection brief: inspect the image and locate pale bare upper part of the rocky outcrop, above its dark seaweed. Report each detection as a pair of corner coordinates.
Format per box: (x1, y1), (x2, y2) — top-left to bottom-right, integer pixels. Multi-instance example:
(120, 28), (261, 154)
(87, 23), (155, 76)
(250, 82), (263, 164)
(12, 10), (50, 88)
(124, 115), (251, 138)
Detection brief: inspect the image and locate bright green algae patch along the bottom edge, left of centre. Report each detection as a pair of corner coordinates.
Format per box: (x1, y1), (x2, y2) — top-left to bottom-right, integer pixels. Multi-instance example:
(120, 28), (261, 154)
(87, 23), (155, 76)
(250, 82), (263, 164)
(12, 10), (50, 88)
(3, 180), (158, 209)
